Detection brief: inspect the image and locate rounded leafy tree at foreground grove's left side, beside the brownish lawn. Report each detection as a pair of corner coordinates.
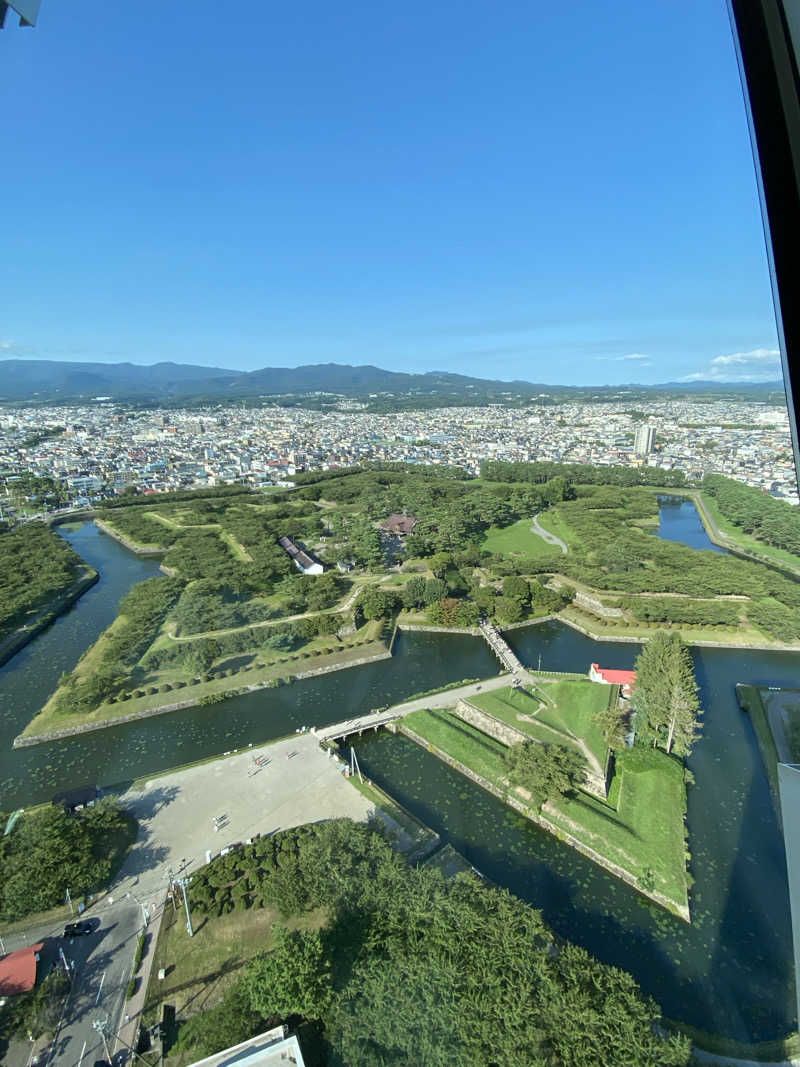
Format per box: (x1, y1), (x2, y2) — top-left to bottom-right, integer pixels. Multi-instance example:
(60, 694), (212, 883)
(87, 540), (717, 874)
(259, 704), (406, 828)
(245, 926), (332, 1019)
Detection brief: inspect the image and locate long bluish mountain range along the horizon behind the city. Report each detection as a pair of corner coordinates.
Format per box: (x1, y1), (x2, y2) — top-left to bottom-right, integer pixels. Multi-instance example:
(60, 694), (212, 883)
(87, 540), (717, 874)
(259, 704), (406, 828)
(0, 360), (784, 411)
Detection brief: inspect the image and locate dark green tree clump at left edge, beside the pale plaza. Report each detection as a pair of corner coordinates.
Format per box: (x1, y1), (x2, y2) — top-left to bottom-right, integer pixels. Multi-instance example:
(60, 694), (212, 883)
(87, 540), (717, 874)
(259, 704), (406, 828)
(0, 800), (135, 921)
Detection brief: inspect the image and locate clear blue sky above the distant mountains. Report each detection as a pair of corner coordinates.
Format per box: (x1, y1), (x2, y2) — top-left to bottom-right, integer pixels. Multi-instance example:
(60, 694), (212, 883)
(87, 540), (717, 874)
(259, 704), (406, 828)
(0, 0), (780, 384)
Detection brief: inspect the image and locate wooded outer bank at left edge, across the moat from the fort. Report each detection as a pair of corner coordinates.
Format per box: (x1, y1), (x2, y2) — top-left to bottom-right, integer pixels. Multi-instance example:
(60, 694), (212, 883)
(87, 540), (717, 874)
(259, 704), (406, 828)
(0, 523), (88, 638)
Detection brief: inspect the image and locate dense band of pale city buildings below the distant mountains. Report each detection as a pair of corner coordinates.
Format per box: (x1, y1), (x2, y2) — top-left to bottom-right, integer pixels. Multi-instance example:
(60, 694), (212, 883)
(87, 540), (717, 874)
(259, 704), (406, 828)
(0, 395), (798, 504)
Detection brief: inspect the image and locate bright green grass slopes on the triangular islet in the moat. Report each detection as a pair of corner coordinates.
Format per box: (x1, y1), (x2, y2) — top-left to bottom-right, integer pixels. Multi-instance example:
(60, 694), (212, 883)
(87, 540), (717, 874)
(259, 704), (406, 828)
(403, 683), (688, 907)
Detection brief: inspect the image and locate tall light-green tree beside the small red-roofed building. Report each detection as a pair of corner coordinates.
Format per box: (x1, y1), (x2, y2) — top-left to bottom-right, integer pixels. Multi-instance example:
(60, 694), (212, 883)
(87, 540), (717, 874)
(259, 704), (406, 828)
(633, 631), (701, 755)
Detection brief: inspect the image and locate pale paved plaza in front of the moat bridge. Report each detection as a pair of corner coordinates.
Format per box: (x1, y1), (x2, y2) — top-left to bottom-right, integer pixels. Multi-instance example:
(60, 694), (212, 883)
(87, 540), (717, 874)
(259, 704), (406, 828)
(111, 734), (373, 904)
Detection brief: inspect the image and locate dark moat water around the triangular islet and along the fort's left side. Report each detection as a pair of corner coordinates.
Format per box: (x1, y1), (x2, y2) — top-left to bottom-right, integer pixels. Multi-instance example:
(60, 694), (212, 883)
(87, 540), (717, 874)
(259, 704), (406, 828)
(0, 516), (800, 1040)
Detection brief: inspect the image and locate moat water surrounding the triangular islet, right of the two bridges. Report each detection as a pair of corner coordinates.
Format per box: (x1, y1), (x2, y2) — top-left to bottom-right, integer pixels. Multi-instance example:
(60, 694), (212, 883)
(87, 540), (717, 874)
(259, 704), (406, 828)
(356, 624), (798, 1040)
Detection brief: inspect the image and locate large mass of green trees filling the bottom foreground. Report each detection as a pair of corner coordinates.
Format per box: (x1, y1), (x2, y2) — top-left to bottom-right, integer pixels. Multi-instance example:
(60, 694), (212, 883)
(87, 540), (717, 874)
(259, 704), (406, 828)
(176, 821), (690, 1067)
